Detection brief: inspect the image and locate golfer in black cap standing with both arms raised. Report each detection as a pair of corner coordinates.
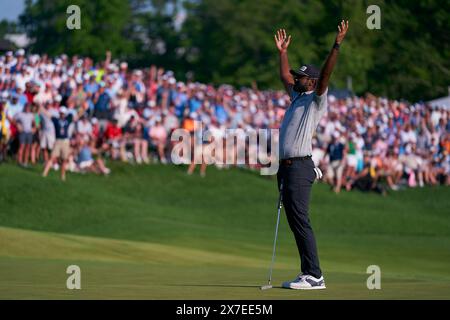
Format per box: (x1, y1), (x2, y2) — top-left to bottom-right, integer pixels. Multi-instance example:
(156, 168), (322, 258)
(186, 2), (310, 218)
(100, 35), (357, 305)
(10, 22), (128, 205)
(275, 20), (348, 290)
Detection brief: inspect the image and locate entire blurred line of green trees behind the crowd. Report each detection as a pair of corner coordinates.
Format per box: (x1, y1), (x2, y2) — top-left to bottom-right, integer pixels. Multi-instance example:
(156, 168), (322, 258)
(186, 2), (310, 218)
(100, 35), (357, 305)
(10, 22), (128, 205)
(15, 0), (450, 101)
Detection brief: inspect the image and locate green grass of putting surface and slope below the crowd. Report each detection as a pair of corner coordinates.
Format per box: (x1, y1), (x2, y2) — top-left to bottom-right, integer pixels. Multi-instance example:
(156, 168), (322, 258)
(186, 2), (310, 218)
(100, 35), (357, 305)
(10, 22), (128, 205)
(0, 163), (450, 299)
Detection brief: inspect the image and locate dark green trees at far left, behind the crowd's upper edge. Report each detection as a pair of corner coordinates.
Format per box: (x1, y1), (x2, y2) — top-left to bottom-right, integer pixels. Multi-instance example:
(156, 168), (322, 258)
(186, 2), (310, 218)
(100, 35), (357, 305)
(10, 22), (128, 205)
(20, 0), (136, 59)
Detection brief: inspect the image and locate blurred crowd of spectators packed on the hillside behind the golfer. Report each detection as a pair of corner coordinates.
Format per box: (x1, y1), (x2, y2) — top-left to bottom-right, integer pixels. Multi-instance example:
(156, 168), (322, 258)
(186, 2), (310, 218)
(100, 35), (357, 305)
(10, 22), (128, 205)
(0, 49), (450, 193)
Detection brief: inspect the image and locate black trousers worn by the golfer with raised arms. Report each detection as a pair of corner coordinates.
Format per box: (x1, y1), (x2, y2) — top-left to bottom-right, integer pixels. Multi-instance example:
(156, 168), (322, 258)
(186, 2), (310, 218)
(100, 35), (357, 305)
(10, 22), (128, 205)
(277, 158), (322, 278)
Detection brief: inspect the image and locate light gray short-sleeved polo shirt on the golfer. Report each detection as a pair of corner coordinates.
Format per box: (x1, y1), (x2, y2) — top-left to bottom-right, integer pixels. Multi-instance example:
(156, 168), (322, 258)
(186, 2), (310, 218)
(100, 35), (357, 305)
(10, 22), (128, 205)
(280, 88), (328, 159)
